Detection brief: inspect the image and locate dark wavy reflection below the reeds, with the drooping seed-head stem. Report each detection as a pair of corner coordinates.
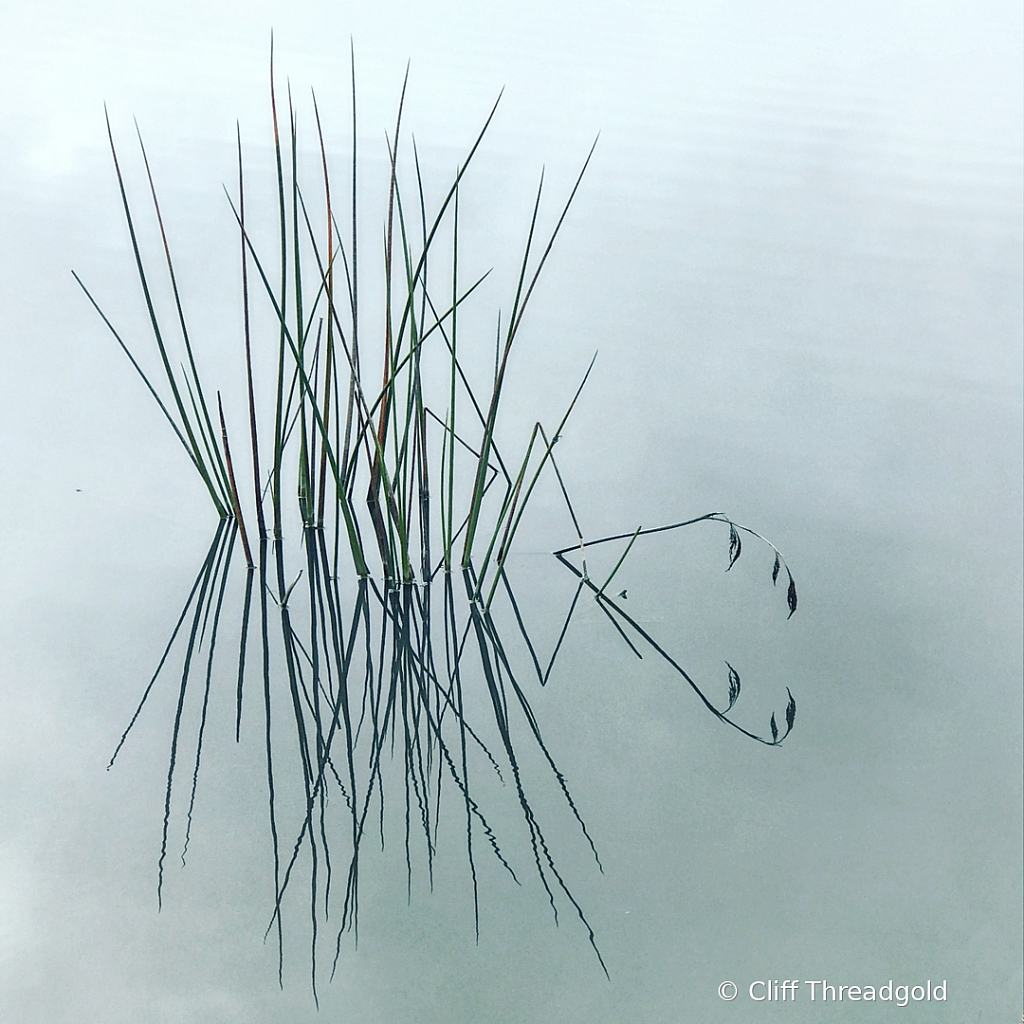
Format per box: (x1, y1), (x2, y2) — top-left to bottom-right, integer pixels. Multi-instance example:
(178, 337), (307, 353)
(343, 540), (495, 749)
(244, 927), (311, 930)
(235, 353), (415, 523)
(111, 513), (796, 992)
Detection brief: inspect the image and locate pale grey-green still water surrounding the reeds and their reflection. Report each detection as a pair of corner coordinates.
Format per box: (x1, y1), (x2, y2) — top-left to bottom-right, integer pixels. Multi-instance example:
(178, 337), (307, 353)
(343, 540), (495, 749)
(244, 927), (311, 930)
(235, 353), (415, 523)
(0, 3), (1022, 1024)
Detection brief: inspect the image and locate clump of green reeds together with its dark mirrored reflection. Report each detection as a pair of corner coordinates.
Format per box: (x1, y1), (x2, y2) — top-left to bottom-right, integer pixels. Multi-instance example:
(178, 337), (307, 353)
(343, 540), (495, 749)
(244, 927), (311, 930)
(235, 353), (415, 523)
(76, 48), (797, 993)
